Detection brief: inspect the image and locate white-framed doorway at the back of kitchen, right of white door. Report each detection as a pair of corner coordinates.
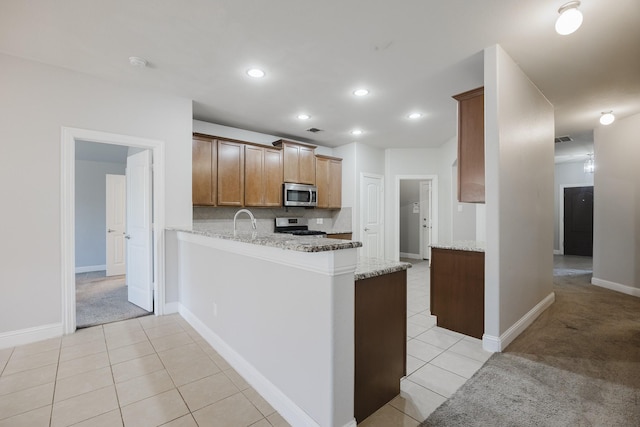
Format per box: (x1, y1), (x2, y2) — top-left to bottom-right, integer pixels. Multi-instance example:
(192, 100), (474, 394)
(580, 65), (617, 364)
(394, 175), (438, 259)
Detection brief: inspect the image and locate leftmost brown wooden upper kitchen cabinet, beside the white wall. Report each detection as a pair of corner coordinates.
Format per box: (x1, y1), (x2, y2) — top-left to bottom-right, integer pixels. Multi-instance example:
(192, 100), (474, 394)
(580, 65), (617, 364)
(191, 134), (218, 206)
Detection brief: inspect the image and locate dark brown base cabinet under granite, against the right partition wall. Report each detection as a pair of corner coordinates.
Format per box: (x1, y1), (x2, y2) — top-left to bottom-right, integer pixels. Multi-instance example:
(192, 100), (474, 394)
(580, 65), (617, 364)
(430, 248), (484, 339)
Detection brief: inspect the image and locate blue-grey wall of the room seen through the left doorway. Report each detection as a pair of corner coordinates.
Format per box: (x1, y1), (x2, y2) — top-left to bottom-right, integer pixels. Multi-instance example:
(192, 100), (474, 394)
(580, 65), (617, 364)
(76, 160), (126, 268)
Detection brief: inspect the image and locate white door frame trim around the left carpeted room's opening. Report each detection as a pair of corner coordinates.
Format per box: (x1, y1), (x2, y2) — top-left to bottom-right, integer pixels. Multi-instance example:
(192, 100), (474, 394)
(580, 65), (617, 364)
(60, 126), (165, 334)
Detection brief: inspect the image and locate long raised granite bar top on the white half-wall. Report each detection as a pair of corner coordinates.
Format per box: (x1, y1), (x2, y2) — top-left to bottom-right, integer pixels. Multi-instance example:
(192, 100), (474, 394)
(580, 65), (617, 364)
(167, 229), (362, 252)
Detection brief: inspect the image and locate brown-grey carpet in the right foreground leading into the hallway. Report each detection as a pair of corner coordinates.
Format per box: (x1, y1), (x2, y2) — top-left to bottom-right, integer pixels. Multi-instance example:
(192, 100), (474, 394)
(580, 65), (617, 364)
(422, 269), (640, 427)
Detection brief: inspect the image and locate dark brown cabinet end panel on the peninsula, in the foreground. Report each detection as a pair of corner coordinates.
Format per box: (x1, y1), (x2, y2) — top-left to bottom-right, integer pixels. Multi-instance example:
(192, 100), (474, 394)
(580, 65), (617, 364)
(354, 270), (407, 422)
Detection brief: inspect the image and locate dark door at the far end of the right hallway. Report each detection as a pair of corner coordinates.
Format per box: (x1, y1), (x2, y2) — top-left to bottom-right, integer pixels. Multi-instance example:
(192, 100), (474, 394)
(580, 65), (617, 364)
(561, 186), (593, 256)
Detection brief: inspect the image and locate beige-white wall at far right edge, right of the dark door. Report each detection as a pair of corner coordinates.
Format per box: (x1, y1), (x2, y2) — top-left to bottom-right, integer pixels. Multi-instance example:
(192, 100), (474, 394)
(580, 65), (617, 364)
(593, 115), (640, 296)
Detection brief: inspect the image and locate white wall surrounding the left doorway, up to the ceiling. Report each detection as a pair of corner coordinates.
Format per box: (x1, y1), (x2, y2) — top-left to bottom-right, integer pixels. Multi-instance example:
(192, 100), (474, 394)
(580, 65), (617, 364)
(0, 55), (192, 337)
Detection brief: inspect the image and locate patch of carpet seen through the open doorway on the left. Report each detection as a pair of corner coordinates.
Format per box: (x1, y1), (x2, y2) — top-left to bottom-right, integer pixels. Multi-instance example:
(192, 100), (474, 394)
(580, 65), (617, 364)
(76, 271), (150, 328)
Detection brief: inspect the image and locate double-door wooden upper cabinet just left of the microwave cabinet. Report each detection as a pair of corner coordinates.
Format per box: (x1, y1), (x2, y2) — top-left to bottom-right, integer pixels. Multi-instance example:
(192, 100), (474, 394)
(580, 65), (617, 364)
(244, 145), (283, 207)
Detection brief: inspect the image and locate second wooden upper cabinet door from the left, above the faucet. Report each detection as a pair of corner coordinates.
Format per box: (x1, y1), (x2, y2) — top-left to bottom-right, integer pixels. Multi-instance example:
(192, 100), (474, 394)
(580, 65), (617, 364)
(218, 141), (245, 206)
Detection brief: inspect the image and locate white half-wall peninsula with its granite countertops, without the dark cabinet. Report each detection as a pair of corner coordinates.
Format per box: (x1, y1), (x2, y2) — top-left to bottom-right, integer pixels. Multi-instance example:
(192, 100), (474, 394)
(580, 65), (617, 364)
(167, 227), (409, 426)
